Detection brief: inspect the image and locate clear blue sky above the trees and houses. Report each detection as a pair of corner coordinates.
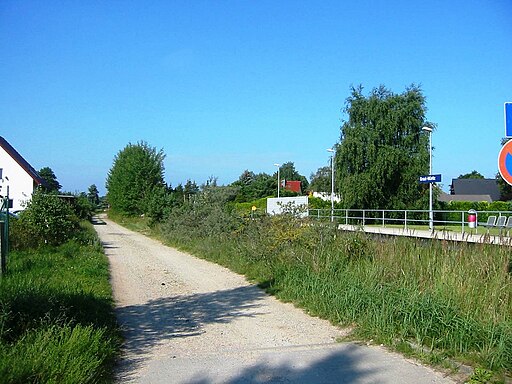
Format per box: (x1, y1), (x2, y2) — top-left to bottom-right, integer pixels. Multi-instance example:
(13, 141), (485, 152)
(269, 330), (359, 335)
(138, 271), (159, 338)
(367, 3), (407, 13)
(0, 0), (512, 193)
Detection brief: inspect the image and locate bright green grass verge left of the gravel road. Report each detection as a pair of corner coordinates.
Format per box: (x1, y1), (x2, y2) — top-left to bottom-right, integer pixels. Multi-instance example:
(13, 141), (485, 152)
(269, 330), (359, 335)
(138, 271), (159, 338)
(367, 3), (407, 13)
(0, 222), (120, 383)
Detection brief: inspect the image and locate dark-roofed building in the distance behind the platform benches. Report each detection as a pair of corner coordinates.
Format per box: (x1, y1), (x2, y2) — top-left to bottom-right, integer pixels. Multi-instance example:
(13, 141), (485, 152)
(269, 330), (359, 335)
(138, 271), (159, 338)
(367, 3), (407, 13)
(439, 179), (501, 203)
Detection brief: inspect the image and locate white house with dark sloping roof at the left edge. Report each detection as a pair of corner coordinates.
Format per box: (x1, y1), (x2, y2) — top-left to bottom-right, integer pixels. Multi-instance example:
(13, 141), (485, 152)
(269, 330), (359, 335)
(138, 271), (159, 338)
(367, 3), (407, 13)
(0, 136), (44, 211)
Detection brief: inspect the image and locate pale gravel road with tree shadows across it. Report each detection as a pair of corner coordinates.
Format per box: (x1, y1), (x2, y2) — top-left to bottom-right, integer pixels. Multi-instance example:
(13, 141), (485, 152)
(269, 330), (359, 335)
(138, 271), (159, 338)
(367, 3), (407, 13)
(95, 219), (452, 384)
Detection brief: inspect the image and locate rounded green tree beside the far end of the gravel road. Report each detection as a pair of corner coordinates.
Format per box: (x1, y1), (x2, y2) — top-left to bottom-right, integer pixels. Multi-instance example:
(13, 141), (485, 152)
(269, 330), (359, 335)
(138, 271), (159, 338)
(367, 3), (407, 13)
(106, 141), (165, 216)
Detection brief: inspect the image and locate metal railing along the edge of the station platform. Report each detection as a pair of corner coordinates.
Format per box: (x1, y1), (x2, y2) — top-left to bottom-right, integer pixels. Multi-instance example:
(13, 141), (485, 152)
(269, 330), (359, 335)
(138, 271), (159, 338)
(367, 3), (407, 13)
(309, 208), (512, 233)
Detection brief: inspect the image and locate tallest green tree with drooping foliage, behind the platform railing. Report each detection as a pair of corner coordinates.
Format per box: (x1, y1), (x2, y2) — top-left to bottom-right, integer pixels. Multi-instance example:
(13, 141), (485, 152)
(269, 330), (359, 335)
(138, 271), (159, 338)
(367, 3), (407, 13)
(335, 85), (432, 209)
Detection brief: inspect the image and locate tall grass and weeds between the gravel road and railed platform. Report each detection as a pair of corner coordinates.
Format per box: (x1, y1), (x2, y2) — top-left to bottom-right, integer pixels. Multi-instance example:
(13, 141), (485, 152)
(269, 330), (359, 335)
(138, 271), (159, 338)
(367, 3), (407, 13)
(149, 210), (512, 374)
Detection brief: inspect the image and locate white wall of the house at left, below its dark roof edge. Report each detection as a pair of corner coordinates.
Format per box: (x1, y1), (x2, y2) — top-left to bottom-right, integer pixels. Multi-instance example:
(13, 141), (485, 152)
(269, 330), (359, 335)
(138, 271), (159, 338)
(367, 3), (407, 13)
(0, 147), (34, 211)
